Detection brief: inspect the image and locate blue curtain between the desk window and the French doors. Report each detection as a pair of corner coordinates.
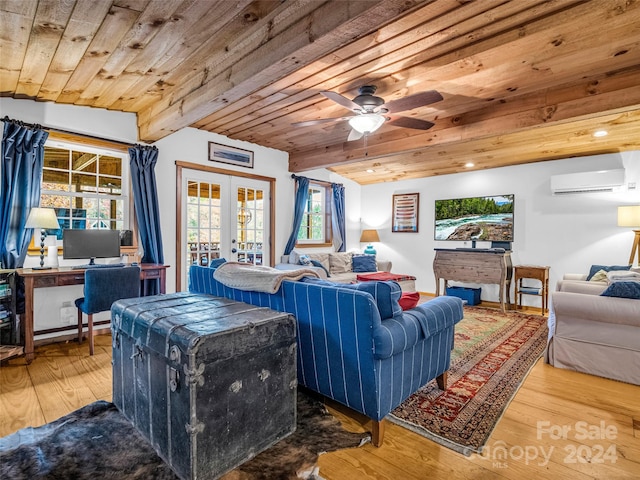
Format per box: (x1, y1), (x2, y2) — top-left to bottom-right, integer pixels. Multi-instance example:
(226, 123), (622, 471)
(129, 145), (164, 295)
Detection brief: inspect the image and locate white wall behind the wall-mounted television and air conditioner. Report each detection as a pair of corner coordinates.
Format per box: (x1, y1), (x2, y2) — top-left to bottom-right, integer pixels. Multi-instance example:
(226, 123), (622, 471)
(362, 151), (640, 306)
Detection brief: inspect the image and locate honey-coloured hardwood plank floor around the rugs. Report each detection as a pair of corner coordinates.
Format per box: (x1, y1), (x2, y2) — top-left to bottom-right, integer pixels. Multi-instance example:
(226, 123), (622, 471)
(0, 336), (640, 480)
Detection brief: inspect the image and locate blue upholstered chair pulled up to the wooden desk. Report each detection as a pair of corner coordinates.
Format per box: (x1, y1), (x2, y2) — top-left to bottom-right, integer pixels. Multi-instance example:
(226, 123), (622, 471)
(75, 266), (140, 355)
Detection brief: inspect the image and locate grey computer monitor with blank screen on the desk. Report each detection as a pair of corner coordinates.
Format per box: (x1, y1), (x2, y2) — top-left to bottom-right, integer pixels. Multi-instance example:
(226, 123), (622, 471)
(62, 228), (120, 265)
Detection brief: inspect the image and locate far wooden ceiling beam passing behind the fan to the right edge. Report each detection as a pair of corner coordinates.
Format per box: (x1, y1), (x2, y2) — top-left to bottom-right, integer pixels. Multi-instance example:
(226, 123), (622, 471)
(289, 69), (640, 172)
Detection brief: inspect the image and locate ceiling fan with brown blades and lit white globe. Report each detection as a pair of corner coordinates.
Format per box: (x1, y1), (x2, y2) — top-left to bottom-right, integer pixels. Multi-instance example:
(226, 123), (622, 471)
(293, 85), (442, 141)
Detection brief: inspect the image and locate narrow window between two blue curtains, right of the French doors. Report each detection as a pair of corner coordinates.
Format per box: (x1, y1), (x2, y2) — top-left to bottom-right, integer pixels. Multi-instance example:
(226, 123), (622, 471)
(297, 182), (331, 246)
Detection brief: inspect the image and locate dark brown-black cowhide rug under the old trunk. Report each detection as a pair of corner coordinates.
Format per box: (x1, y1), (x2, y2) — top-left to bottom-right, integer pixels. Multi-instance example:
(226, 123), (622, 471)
(0, 392), (370, 480)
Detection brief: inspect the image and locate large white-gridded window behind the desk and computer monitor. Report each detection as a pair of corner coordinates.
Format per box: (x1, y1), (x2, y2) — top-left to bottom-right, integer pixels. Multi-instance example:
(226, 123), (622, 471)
(40, 141), (130, 243)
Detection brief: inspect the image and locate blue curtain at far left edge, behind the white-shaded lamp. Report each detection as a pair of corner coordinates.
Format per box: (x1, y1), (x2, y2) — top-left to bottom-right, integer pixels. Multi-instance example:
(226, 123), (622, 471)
(0, 117), (49, 268)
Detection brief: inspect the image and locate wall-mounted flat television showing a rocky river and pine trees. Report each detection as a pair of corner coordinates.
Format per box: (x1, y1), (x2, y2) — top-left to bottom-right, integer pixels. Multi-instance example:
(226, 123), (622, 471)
(435, 194), (514, 242)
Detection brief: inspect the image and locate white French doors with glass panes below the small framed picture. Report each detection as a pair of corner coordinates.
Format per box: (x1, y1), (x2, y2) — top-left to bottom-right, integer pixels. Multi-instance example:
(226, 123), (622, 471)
(180, 169), (271, 286)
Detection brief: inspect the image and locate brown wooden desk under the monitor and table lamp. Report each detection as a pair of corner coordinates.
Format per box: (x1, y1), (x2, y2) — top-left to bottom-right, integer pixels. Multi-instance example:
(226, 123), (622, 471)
(16, 263), (169, 363)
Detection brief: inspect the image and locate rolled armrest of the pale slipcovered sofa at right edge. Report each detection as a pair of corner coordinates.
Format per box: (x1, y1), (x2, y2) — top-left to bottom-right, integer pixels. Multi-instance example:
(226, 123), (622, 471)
(551, 292), (640, 327)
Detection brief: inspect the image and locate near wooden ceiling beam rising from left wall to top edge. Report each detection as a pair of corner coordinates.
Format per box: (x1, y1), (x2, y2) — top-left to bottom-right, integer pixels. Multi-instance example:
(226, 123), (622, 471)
(138, 0), (426, 141)
